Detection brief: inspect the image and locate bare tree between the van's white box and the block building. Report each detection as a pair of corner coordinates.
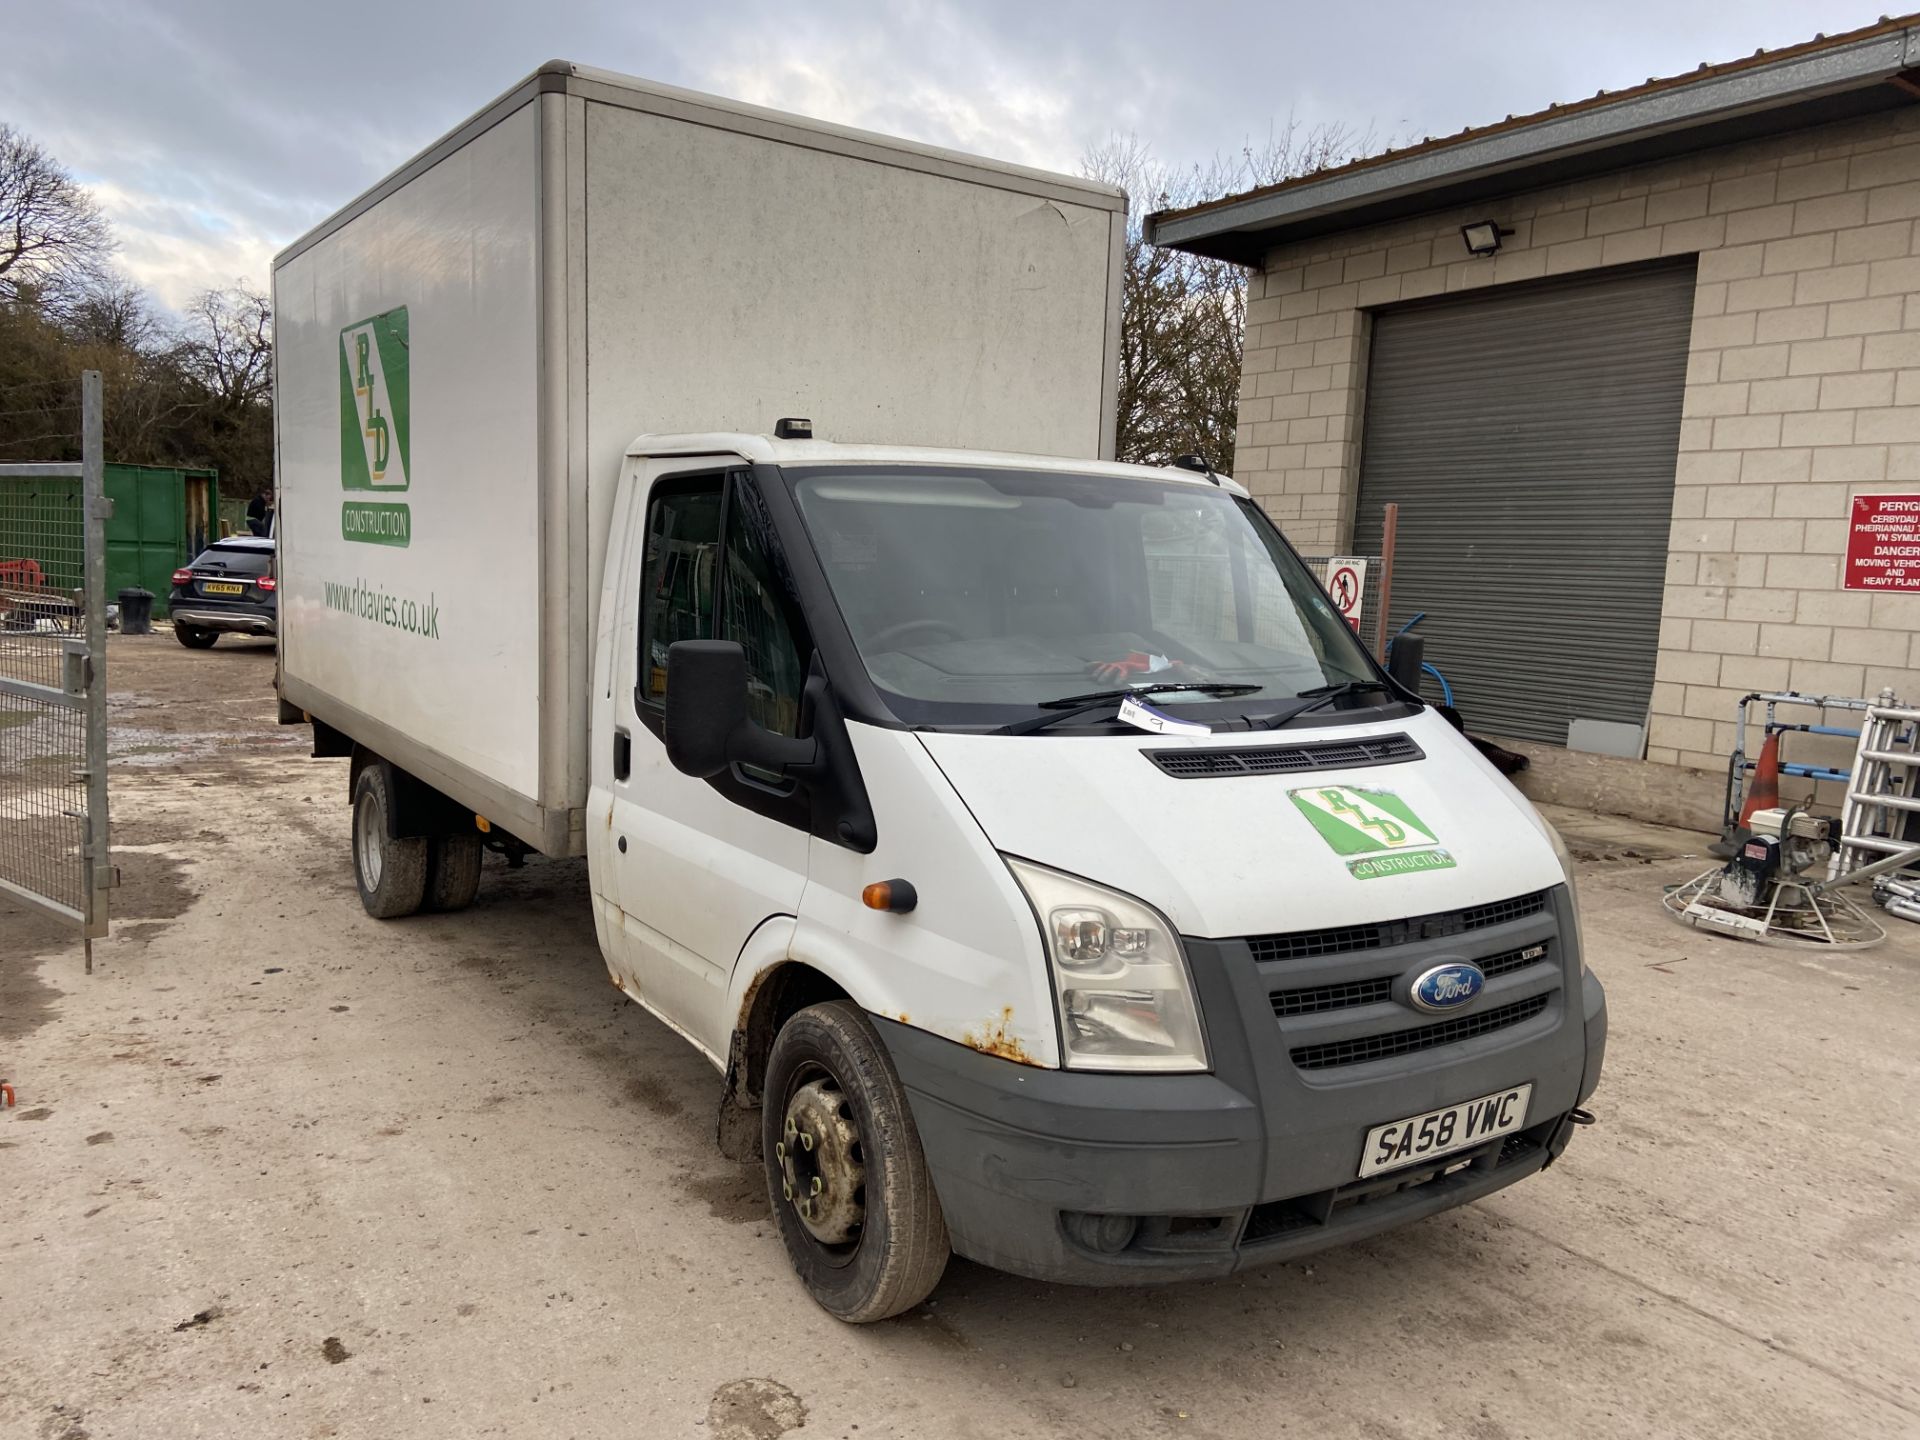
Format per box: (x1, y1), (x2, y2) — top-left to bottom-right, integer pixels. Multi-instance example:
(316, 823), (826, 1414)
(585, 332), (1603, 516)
(1081, 119), (1375, 470)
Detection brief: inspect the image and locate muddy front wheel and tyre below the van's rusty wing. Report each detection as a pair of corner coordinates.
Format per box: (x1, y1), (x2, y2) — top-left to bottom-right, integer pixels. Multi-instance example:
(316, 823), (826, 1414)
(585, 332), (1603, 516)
(760, 1000), (952, 1325)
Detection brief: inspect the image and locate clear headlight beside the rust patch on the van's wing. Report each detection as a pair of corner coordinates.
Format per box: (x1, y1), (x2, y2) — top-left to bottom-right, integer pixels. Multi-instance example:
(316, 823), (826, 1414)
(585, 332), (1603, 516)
(1006, 858), (1208, 1071)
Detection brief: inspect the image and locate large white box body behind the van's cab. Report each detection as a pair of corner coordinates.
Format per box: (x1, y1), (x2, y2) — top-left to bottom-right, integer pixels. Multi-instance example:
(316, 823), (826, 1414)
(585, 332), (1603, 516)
(273, 61), (1125, 854)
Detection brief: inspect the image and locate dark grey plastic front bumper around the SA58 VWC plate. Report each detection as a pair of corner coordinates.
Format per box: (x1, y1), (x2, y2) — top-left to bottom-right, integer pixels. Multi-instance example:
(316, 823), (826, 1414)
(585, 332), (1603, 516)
(874, 887), (1607, 1284)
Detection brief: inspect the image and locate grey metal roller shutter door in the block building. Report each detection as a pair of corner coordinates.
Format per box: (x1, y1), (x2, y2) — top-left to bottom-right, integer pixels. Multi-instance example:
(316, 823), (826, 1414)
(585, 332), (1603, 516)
(1356, 259), (1693, 751)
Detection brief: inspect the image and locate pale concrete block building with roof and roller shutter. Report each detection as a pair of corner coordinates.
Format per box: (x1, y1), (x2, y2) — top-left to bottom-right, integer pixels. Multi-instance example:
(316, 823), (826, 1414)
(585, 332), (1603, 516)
(1146, 17), (1920, 824)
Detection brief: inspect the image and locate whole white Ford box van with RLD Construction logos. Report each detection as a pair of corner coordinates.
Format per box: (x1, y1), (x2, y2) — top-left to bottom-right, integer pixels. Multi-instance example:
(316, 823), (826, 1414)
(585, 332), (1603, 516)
(275, 65), (1605, 1321)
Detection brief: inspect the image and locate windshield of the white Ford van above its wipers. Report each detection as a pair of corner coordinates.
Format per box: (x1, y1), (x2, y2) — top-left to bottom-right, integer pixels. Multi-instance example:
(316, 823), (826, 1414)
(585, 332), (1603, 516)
(787, 467), (1379, 726)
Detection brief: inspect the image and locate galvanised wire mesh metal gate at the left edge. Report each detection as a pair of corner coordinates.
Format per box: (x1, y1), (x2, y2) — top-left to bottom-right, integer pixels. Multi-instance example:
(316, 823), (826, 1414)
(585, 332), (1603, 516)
(0, 371), (113, 970)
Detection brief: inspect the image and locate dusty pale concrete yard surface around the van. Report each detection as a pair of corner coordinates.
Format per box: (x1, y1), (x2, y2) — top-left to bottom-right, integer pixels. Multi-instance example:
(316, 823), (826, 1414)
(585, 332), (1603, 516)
(0, 634), (1920, 1440)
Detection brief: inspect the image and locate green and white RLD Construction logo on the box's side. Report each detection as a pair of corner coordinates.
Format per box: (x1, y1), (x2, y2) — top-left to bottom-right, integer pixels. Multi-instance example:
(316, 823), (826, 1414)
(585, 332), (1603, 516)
(340, 305), (413, 545)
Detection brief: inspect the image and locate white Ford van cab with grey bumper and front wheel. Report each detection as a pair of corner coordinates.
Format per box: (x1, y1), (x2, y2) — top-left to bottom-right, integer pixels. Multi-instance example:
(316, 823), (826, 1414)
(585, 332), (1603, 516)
(586, 434), (1607, 1321)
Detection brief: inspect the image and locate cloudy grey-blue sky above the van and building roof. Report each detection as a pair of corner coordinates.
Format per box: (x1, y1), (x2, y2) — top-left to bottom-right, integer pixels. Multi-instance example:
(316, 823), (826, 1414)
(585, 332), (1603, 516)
(0, 0), (1885, 305)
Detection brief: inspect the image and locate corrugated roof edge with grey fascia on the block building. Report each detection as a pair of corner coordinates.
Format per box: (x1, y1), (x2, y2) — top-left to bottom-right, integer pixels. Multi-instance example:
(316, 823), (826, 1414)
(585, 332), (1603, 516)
(1146, 13), (1920, 263)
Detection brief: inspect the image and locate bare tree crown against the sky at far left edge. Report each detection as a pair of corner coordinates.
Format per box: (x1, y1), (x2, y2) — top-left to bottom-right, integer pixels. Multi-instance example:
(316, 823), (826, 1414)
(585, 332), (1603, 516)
(0, 125), (113, 300)
